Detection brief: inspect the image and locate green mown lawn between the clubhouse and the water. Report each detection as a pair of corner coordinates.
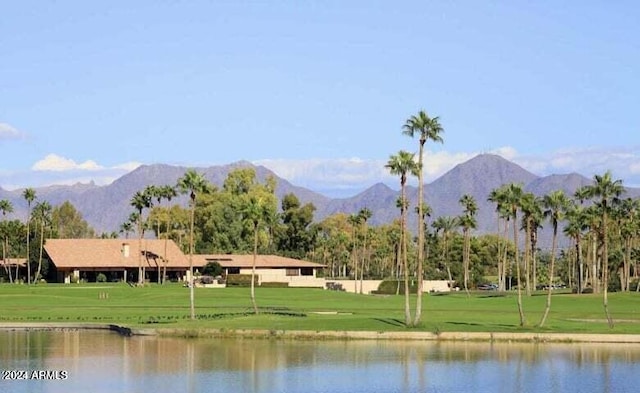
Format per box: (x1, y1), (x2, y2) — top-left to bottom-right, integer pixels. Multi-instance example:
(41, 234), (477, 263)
(0, 284), (640, 334)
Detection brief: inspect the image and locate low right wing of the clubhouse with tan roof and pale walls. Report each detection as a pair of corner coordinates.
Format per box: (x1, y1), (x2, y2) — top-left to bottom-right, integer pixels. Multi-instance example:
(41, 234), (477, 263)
(193, 254), (325, 288)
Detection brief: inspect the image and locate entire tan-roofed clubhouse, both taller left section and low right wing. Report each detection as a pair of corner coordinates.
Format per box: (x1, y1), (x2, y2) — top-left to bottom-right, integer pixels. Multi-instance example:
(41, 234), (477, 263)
(44, 239), (325, 288)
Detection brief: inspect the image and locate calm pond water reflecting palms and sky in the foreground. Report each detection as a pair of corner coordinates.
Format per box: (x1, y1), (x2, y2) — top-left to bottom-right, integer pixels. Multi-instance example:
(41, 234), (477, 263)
(0, 331), (640, 393)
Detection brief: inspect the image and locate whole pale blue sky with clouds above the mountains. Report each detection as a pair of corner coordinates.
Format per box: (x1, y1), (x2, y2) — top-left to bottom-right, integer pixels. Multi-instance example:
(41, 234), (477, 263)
(0, 0), (640, 195)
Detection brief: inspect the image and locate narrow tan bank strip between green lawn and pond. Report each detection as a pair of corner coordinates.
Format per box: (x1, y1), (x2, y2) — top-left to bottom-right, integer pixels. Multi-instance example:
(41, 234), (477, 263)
(0, 322), (640, 344)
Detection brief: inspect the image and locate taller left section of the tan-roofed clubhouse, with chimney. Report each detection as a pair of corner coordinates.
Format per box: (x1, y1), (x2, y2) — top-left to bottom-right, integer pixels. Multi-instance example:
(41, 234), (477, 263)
(44, 239), (189, 283)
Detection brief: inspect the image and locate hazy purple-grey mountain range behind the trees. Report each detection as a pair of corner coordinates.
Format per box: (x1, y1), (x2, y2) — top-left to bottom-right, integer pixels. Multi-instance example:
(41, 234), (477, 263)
(0, 154), (640, 247)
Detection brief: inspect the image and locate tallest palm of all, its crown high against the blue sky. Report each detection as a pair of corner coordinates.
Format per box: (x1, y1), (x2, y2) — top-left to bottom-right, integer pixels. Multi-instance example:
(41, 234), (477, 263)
(402, 110), (444, 325)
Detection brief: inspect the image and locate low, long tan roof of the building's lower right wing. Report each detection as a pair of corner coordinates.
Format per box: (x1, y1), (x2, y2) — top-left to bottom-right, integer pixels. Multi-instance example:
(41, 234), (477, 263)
(193, 254), (324, 269)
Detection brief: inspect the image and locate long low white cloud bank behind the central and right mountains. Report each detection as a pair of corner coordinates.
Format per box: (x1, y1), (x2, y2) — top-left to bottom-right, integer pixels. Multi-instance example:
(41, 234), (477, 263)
(254, 146), (640, 196)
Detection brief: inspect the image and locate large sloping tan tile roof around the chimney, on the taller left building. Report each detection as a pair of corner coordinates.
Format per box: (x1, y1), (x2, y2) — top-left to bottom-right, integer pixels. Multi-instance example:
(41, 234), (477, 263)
(44, 239), (189, 269)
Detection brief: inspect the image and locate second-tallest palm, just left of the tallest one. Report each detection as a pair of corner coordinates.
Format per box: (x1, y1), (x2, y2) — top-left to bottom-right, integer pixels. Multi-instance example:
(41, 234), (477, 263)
(385, 150), (417, 327)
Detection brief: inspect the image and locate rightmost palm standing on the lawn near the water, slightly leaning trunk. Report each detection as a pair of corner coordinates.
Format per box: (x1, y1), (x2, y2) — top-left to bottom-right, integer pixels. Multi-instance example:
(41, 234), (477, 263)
(586, 171), (624, 328)
